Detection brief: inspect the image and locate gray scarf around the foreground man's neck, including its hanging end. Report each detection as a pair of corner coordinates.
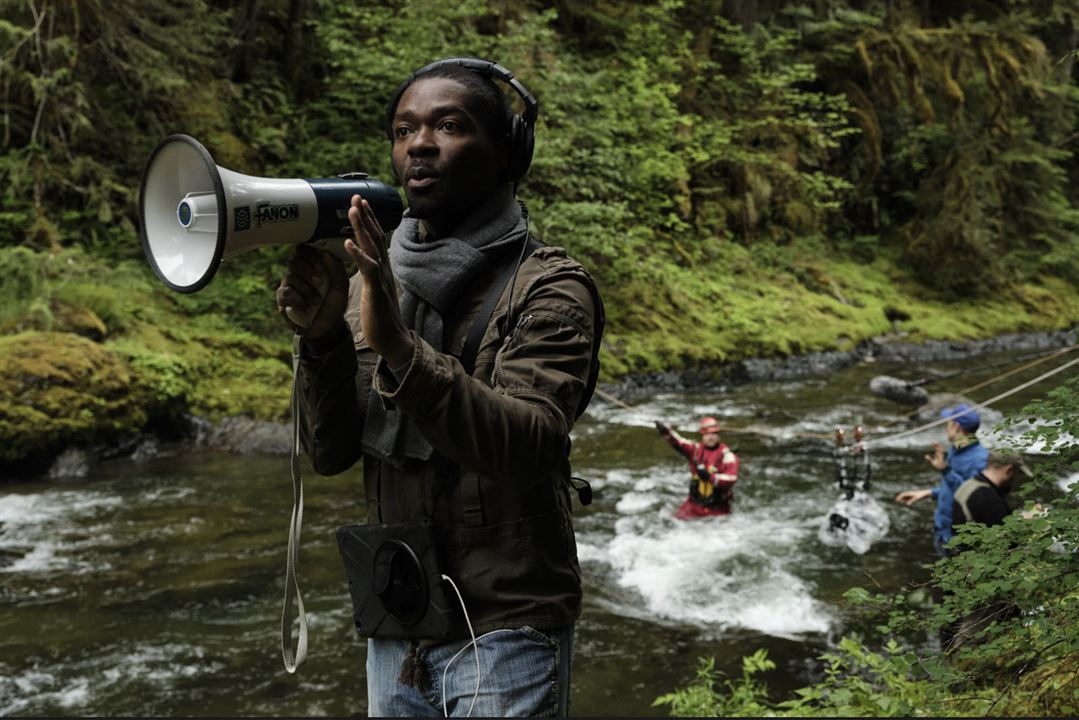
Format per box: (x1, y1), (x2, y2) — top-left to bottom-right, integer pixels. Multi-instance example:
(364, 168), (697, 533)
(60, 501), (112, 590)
(363, 186), (527, 466)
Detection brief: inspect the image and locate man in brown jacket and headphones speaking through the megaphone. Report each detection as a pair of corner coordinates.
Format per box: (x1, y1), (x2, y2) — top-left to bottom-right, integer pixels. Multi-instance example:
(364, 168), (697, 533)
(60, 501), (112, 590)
(277, 58), (603, 717)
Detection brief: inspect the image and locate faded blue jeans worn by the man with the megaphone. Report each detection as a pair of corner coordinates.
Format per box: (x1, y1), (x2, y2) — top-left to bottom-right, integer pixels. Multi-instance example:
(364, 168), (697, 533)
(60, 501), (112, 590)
(367, 625), (573, 718)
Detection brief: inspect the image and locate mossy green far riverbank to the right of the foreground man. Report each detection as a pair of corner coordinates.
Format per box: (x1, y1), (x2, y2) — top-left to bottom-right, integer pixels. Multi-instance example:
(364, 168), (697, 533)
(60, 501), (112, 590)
(601, 242), (1079, 380)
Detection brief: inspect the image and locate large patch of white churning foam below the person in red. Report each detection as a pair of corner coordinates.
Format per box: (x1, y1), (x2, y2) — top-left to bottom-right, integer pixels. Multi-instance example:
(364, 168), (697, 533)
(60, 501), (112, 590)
(578, 467), (833, 638)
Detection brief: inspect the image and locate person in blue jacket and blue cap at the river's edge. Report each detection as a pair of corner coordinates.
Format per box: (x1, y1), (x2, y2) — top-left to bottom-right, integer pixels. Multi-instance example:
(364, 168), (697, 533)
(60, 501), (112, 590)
(896, 403), (989, 557)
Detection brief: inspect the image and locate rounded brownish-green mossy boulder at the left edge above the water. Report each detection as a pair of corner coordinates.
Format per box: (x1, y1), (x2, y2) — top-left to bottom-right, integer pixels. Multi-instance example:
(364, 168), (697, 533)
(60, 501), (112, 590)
(0, 331), (152, 463)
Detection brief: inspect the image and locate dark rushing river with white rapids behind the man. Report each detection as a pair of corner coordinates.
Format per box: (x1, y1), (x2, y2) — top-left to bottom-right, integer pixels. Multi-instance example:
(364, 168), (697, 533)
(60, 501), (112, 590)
(0, 347), (1074, 717)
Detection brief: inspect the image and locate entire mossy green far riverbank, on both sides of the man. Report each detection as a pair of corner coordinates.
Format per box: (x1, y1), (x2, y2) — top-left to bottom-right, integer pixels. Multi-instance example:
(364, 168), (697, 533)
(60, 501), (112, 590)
(0, 239), (1079, 462)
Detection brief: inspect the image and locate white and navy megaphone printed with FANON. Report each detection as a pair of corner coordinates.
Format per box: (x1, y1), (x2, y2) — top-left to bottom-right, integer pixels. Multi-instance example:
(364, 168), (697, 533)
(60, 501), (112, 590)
(138, 134), (404, 293)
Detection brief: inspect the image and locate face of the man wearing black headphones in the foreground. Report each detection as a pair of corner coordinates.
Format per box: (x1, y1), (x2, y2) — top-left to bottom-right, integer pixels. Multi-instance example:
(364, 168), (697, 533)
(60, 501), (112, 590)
(391, 78), (506, 234)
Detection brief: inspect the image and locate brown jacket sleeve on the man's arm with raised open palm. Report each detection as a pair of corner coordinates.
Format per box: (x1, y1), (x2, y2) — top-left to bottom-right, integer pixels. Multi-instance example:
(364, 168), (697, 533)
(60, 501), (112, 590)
(373, 268), (596, 481)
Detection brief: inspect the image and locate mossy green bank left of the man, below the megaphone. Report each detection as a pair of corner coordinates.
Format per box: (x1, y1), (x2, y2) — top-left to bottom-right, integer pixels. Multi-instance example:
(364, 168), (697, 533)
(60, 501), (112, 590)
(0, 247), (291, 465)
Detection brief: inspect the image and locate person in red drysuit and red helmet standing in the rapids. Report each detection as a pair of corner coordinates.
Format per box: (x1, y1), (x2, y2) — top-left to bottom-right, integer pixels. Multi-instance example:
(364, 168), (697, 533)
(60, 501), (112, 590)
(656, 417), (738, 520)
